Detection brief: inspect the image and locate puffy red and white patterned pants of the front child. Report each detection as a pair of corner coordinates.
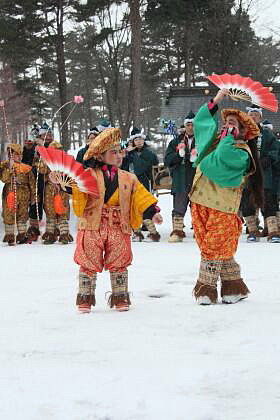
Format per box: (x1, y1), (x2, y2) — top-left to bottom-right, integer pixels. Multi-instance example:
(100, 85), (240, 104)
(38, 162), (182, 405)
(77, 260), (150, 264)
(74, 208), (132, 276)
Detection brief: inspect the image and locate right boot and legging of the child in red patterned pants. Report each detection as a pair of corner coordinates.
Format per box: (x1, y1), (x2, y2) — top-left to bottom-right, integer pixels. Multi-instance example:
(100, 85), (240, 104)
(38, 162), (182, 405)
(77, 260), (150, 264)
(108, 270), (131, 312)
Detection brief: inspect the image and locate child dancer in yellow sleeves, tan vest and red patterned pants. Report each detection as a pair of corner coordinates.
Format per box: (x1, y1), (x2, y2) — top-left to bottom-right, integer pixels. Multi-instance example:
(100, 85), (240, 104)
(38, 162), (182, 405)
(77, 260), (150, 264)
(52, 128), (162, 312)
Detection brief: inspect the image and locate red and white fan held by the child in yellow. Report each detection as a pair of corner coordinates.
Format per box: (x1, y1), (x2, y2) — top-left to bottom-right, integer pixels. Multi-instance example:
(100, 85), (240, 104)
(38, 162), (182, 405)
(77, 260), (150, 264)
(36, 146), (99, 198)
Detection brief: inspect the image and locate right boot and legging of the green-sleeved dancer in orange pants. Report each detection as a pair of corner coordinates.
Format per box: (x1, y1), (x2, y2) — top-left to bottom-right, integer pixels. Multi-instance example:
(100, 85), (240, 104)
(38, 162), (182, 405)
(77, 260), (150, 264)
(220, 258), (250, 303)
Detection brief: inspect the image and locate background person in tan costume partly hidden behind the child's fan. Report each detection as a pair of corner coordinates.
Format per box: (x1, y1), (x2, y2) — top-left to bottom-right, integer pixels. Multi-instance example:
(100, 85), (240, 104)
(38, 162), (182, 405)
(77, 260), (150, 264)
(37, 141), (73, 245)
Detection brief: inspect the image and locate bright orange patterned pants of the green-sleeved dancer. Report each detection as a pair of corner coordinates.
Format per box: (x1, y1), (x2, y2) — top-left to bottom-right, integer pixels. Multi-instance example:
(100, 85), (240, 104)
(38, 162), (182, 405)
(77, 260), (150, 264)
(191, 203), (242, 261)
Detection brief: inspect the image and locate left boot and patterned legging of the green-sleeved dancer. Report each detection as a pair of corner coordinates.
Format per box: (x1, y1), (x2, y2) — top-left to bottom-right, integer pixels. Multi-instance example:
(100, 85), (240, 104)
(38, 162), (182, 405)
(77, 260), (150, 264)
(193, 258), (222, 305)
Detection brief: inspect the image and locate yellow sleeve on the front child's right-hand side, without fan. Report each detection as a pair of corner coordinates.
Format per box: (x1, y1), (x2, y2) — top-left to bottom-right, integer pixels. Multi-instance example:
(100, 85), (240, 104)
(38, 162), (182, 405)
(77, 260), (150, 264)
(130, 181), (157, 229)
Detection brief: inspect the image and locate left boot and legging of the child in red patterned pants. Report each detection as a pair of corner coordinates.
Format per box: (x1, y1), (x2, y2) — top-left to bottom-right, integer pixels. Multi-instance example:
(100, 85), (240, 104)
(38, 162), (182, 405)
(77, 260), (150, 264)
(76, 271), (97, 313)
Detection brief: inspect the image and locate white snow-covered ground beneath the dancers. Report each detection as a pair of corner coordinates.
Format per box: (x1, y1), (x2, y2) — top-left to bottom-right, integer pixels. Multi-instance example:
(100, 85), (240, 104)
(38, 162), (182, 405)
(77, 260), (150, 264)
(0, 196), (280, 420)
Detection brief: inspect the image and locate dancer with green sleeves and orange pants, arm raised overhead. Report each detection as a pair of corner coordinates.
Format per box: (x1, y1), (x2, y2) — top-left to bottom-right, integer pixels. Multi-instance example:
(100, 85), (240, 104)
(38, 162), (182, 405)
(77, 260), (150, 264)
(189, 89), (263, 305)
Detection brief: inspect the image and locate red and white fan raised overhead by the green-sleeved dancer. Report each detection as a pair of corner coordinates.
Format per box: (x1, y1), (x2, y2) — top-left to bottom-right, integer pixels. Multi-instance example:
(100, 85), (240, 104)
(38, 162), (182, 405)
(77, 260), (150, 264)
(207, 73), (278, 112)
